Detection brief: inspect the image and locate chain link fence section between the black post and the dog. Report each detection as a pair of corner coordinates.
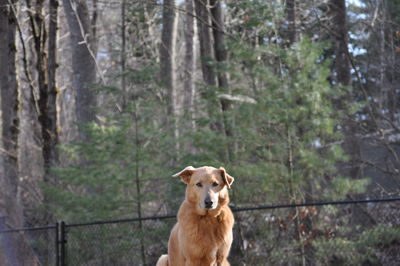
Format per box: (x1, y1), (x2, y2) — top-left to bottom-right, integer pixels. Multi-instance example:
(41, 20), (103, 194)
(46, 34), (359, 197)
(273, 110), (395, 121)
(66, 215), (176, 266)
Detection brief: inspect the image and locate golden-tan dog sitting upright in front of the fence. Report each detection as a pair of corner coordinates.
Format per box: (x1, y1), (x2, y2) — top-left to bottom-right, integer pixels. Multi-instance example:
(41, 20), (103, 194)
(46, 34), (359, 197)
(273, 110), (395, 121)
(157, 166), (234, 266)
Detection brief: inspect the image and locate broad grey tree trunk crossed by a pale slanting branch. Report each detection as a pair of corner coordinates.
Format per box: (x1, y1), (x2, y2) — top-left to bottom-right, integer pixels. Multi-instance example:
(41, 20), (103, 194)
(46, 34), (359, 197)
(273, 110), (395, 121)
(63, 0), (96, 141)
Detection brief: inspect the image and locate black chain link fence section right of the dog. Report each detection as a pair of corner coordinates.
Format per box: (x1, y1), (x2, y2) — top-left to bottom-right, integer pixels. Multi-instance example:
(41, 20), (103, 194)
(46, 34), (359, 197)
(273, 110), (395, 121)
(230, 198), (400, 265)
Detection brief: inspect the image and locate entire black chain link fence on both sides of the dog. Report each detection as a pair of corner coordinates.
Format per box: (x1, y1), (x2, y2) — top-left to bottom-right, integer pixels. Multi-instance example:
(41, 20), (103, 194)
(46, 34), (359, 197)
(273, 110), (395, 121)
(0, 197), (400, 266)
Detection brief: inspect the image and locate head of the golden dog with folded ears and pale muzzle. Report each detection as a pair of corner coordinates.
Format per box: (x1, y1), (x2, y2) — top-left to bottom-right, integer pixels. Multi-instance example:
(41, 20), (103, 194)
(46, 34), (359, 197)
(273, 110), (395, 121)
(173, 166), (234, 212)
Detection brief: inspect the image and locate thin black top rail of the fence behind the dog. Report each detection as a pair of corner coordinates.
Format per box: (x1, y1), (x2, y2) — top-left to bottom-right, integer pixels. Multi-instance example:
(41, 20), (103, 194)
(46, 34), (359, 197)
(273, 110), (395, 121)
(0, 196), (400, 233)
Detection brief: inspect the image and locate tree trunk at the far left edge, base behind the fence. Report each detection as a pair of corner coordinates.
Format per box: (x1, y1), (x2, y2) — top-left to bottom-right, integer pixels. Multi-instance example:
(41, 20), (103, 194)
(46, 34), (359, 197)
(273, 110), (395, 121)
(0, 0), (35, 265)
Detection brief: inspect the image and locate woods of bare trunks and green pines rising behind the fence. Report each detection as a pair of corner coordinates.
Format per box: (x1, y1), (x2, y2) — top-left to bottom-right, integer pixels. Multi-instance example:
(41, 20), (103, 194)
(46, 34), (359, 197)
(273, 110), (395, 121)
(0, 0), (400, 265)
